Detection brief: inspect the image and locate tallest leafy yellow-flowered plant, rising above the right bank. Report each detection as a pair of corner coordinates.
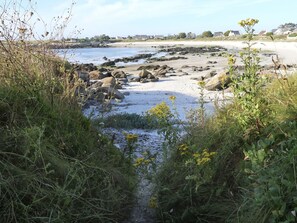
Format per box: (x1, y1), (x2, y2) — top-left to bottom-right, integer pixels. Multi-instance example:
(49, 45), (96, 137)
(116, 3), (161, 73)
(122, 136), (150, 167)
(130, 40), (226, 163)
(228, 19), (264, 134)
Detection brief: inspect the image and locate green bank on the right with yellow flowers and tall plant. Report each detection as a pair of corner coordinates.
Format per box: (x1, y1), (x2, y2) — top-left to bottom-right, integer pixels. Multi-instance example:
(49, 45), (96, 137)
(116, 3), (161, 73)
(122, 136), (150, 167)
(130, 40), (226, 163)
(156, 19), (297, 223)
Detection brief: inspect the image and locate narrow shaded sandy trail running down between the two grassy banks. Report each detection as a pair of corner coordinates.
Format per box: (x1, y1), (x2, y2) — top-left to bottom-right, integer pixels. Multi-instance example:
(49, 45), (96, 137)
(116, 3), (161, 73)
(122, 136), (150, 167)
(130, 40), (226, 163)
(104, 128), (163, 223)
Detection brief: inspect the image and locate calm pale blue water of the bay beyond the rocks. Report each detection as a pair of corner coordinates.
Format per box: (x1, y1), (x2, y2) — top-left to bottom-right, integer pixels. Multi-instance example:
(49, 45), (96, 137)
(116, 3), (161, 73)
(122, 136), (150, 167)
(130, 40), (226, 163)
(58, 47), (156, 65)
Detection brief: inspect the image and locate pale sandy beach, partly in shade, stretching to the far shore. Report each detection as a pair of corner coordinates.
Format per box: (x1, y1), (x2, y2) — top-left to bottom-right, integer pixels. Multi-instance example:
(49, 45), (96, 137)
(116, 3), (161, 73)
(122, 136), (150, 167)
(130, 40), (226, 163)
(85, 41), (297, 120)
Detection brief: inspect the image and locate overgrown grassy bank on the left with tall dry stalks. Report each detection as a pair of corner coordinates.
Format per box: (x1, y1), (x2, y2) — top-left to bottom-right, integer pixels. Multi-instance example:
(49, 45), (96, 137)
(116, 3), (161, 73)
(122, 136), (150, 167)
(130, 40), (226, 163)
(0, 1), (135, 223)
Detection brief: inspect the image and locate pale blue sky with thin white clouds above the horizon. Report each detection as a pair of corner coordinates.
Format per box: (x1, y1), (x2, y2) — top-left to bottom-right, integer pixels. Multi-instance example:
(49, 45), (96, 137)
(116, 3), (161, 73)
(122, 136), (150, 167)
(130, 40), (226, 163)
(0, 0), (297, 37)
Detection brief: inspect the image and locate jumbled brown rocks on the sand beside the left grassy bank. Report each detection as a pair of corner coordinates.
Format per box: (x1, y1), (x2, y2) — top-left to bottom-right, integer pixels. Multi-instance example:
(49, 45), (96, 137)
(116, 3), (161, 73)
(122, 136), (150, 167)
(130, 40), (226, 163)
(73, 61), (174, 104)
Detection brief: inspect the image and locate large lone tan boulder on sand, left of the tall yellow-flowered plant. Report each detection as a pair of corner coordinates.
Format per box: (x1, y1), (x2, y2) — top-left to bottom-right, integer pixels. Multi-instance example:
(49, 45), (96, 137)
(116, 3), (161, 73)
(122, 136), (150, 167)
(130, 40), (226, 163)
(205, 72), (231, 91)
